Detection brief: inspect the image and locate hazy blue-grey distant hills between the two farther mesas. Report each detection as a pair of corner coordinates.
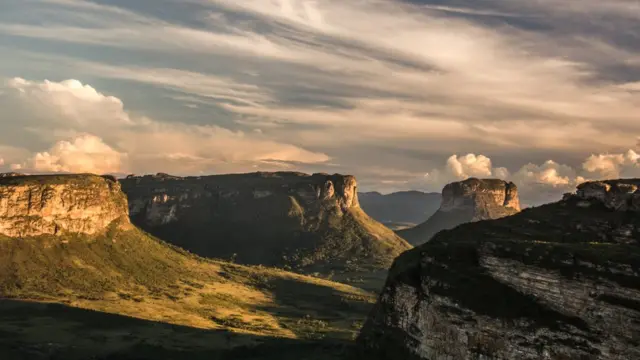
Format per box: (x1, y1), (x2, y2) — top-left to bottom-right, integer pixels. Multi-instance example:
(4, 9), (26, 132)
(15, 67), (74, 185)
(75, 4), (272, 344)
(358, 191), (442, 230)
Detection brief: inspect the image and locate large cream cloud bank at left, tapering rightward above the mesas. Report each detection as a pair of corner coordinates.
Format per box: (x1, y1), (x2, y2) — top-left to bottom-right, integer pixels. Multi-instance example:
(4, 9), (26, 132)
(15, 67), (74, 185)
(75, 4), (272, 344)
(0, 78), (329, 174)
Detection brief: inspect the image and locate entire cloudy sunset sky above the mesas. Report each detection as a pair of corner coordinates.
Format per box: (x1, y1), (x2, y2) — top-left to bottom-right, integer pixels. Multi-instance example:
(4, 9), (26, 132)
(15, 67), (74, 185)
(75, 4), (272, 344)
(0, 0), (640, 205)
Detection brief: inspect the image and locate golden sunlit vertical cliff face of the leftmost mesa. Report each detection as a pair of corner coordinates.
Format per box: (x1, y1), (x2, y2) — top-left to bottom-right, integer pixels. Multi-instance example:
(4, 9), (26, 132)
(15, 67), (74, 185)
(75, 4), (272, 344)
(0, 174), (128, 237)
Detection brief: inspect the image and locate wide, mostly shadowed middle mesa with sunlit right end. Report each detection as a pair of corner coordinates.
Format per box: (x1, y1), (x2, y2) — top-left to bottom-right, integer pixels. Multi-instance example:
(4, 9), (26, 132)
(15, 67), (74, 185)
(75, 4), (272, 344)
(121, 172), (410, 267)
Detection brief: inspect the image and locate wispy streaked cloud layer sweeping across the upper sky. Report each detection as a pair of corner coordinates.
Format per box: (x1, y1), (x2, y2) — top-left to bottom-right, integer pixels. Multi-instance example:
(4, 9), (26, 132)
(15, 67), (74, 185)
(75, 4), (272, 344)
(0, 0), (640, 202)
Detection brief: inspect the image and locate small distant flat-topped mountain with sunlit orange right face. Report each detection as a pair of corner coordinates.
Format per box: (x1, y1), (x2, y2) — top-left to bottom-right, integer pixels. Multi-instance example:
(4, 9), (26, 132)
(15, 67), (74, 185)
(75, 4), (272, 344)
(398, 178), (520, 245)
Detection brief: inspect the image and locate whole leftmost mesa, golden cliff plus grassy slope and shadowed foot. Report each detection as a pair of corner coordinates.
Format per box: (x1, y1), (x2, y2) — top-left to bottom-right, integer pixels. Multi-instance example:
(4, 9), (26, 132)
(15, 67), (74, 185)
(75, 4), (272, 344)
(0, 175), (374, 360)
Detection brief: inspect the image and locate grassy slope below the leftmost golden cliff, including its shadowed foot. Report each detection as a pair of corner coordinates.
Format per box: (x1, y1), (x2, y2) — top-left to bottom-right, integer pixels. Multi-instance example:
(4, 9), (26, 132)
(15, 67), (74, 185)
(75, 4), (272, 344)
(0, 225), (375, 359)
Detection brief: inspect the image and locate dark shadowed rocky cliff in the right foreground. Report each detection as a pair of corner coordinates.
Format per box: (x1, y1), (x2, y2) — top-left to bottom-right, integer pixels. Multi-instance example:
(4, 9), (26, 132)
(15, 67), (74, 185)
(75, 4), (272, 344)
(359, 180), (640, 360)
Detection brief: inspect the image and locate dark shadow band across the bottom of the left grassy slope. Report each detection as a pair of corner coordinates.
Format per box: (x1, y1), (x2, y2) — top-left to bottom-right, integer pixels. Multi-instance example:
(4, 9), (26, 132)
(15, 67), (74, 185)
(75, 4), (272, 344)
(0, 300), (350, 360)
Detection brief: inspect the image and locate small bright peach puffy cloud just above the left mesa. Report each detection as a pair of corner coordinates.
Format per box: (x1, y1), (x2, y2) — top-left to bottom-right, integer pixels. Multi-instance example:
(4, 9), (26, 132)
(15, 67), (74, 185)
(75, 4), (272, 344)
(12, 135), (126, 174)
